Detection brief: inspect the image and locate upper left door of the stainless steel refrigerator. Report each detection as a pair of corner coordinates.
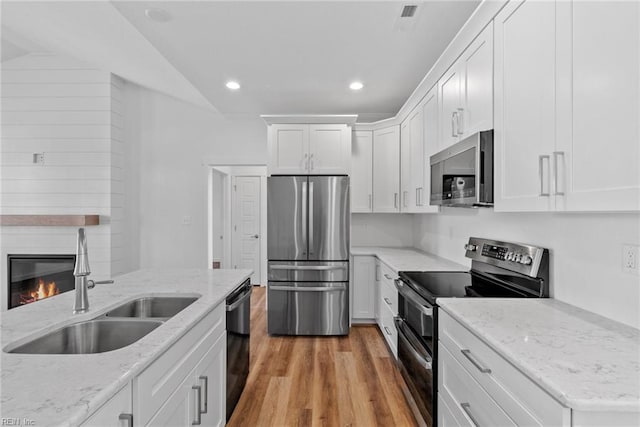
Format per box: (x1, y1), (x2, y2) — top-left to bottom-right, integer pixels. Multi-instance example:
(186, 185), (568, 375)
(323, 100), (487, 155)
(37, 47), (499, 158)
(267, 176), (308, 260)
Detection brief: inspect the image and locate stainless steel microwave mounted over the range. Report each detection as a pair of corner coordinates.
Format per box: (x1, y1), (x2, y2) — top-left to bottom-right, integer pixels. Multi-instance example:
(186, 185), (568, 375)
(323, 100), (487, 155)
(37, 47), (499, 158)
(430, 130), (493, 208)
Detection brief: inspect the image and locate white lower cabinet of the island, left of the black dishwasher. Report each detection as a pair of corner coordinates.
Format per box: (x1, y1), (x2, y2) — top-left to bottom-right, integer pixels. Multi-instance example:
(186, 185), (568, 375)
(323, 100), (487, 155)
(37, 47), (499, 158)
(82, 303), (227, 427)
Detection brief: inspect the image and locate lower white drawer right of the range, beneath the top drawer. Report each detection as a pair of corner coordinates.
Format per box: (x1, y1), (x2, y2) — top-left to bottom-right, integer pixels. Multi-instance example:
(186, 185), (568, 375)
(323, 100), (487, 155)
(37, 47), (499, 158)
(438, 347), (516, 427)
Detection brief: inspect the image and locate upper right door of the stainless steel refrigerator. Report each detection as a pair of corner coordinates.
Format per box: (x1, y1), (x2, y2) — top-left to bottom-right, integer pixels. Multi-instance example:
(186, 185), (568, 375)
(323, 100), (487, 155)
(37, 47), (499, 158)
(308, 176), (351, 261)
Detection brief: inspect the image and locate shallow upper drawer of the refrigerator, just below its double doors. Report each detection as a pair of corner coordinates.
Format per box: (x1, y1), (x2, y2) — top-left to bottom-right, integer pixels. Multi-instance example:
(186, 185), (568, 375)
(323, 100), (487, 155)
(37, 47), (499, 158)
(269, 261), (349, 282)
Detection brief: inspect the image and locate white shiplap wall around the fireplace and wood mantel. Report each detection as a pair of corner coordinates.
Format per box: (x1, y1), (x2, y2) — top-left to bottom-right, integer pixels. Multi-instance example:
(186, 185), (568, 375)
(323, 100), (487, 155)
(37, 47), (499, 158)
(0, 54), (124, 310)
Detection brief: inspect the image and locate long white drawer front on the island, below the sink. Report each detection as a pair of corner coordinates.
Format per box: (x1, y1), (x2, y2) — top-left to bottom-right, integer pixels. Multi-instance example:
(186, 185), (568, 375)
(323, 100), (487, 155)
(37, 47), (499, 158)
(134, 302), (226, 425)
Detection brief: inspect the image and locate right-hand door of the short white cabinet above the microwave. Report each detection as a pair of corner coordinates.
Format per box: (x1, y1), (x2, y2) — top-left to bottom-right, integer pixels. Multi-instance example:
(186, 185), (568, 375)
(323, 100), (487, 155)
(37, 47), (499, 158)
(459, 22), (496, 138)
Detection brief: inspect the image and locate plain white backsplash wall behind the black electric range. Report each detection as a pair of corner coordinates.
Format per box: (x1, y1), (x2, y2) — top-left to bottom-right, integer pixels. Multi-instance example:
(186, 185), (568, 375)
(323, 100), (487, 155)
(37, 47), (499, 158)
(414, 208), (640, 327)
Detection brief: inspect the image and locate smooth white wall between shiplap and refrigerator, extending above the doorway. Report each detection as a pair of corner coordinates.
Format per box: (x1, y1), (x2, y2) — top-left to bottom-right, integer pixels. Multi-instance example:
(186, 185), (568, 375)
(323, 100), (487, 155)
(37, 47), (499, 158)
(124, 83), (267, 268)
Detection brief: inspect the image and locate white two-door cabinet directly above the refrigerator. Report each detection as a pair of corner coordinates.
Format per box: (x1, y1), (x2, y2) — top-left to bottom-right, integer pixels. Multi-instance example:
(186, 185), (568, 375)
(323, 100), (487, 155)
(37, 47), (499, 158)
(268, 124), (351, 175)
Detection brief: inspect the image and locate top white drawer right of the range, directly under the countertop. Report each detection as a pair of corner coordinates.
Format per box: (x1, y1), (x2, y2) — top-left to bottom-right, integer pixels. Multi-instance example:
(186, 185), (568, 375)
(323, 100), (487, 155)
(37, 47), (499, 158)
(439, 310), (570, 426)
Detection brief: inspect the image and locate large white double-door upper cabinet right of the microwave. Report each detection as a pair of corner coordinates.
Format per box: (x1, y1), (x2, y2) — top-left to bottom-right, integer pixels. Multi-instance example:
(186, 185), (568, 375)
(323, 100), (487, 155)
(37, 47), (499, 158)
(495, 1), (640, 211)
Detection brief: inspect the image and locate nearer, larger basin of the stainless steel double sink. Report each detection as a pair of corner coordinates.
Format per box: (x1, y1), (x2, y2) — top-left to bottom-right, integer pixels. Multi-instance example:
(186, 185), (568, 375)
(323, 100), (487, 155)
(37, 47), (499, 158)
(8, 319), (162, 354)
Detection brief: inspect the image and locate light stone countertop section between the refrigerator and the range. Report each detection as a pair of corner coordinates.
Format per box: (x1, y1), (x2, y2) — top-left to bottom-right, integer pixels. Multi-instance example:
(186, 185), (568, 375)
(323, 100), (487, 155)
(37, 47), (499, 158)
(351, 246), (469, 273)
